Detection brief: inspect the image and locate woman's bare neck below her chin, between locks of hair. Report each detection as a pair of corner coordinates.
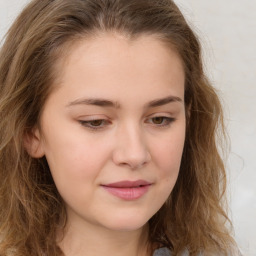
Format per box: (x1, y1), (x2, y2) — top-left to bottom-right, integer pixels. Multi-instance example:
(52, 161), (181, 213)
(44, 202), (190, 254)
(59, 220), (151, 256)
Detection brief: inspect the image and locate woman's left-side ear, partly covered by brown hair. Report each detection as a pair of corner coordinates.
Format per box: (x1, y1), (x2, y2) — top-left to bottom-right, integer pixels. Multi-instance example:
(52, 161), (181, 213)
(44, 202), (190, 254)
(23, 128), (44, 158)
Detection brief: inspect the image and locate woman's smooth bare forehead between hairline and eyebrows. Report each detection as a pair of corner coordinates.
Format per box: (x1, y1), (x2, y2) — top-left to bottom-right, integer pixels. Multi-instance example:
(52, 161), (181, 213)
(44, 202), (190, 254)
(49, 33), (185, 104)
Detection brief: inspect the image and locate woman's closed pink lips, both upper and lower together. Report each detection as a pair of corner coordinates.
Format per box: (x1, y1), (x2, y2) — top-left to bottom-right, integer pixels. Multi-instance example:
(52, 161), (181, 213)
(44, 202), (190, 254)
(102, 180), (152, 200)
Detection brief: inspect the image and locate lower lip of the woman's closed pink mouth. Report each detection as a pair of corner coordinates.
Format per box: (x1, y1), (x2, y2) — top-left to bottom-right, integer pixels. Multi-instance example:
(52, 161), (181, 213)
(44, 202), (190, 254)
(102, 185), (150, 200)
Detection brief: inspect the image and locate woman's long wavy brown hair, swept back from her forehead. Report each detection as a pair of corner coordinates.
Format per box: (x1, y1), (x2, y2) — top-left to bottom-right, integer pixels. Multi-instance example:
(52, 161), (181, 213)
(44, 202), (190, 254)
(0, 0), (236, 256)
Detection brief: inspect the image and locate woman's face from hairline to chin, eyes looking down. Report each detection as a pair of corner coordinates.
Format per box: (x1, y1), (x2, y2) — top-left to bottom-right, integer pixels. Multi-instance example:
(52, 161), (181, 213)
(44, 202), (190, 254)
(33, 34), (186, 231)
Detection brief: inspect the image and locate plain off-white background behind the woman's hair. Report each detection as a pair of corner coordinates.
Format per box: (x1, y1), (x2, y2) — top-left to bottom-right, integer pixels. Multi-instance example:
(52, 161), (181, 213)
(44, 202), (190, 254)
(0, 0), (256, 256)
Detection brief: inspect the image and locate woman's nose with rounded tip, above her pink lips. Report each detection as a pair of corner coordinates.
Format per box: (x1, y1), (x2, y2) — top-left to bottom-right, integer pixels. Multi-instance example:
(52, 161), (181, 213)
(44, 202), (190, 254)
(113, 122), (151, 170)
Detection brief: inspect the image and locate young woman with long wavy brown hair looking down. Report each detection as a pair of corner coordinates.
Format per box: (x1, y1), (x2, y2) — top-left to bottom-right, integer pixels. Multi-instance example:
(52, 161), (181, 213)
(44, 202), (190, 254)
(0, 0), (238, 256)
